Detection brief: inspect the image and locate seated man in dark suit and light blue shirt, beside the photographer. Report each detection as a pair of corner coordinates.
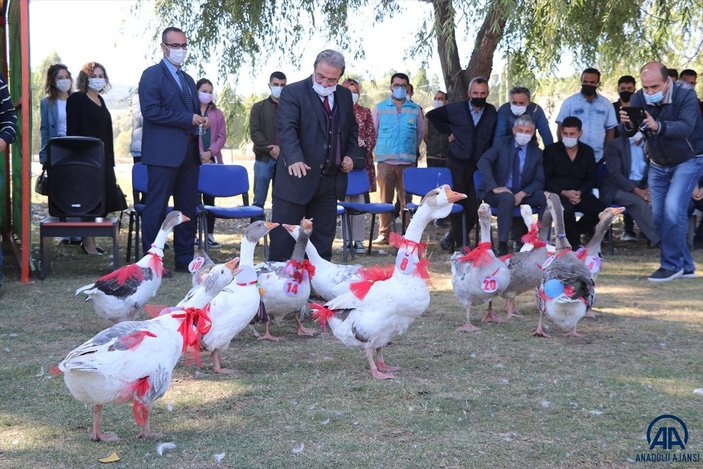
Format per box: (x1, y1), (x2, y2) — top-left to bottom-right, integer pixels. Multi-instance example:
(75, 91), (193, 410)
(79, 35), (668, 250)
(600, 132), (660, 246)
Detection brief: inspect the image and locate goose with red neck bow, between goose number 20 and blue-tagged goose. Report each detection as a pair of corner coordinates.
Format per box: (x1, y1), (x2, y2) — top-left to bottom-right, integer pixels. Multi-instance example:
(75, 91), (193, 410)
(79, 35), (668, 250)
(500, 204), (552, 318)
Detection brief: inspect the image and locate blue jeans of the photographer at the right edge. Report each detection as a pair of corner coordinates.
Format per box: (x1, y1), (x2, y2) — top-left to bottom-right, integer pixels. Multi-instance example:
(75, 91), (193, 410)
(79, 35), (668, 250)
(649, 158), (703, 272)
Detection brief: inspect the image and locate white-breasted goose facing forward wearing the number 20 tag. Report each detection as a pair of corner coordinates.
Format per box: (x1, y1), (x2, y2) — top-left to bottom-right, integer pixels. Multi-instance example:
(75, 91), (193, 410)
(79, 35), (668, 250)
(451, 203), (510, 332)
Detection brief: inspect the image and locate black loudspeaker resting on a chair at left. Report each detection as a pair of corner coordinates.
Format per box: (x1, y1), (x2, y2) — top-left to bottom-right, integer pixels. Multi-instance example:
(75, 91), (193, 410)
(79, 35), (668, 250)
(47, 137), (105, 217)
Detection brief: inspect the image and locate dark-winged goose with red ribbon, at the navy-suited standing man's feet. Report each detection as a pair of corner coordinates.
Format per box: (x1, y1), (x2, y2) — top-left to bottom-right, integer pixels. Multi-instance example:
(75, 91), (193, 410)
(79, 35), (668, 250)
(76, 211), (189, 323)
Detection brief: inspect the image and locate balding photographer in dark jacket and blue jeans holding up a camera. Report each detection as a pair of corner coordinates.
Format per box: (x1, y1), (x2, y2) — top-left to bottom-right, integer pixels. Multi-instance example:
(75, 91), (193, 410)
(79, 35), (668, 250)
(620, 62), (703, 282)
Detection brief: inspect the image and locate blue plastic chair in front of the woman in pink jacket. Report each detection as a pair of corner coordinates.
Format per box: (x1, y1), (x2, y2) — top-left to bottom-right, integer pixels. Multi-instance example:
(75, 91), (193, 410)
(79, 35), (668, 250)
(195, 164), (268, 254)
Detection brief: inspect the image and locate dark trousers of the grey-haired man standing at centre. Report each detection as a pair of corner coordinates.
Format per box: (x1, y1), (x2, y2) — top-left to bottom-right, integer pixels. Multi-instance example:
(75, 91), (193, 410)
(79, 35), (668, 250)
(269, 176), (337, 261)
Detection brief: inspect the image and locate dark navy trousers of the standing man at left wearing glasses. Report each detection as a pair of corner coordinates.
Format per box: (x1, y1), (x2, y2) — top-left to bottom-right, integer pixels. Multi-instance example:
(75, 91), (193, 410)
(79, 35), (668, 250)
(142, 140), (200, 268)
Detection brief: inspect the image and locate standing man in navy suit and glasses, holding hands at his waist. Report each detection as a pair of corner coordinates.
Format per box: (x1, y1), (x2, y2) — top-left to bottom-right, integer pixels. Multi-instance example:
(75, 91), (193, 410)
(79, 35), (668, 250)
(139, 27), (207, 272)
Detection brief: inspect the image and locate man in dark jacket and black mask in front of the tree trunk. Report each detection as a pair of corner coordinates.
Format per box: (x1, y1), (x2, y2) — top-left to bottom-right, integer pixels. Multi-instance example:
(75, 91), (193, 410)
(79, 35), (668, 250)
(427, 77), (498, 250)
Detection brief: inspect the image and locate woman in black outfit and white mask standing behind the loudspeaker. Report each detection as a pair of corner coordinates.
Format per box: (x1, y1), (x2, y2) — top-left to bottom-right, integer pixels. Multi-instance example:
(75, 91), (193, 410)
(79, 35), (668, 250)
(66, 62), (127, 254)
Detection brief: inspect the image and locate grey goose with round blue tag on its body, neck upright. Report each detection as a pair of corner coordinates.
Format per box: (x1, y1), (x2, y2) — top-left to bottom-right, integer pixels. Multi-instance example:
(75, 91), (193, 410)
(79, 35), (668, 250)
(533, 193), (595, 337)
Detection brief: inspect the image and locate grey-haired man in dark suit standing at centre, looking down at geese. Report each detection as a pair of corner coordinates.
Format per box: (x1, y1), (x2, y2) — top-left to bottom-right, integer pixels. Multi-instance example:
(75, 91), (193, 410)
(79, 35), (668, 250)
(269, 50), (359, 261)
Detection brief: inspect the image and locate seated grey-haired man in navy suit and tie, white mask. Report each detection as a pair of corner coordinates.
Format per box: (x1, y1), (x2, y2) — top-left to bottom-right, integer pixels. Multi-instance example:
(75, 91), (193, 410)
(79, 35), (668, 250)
(478, 115), (547, 256)
